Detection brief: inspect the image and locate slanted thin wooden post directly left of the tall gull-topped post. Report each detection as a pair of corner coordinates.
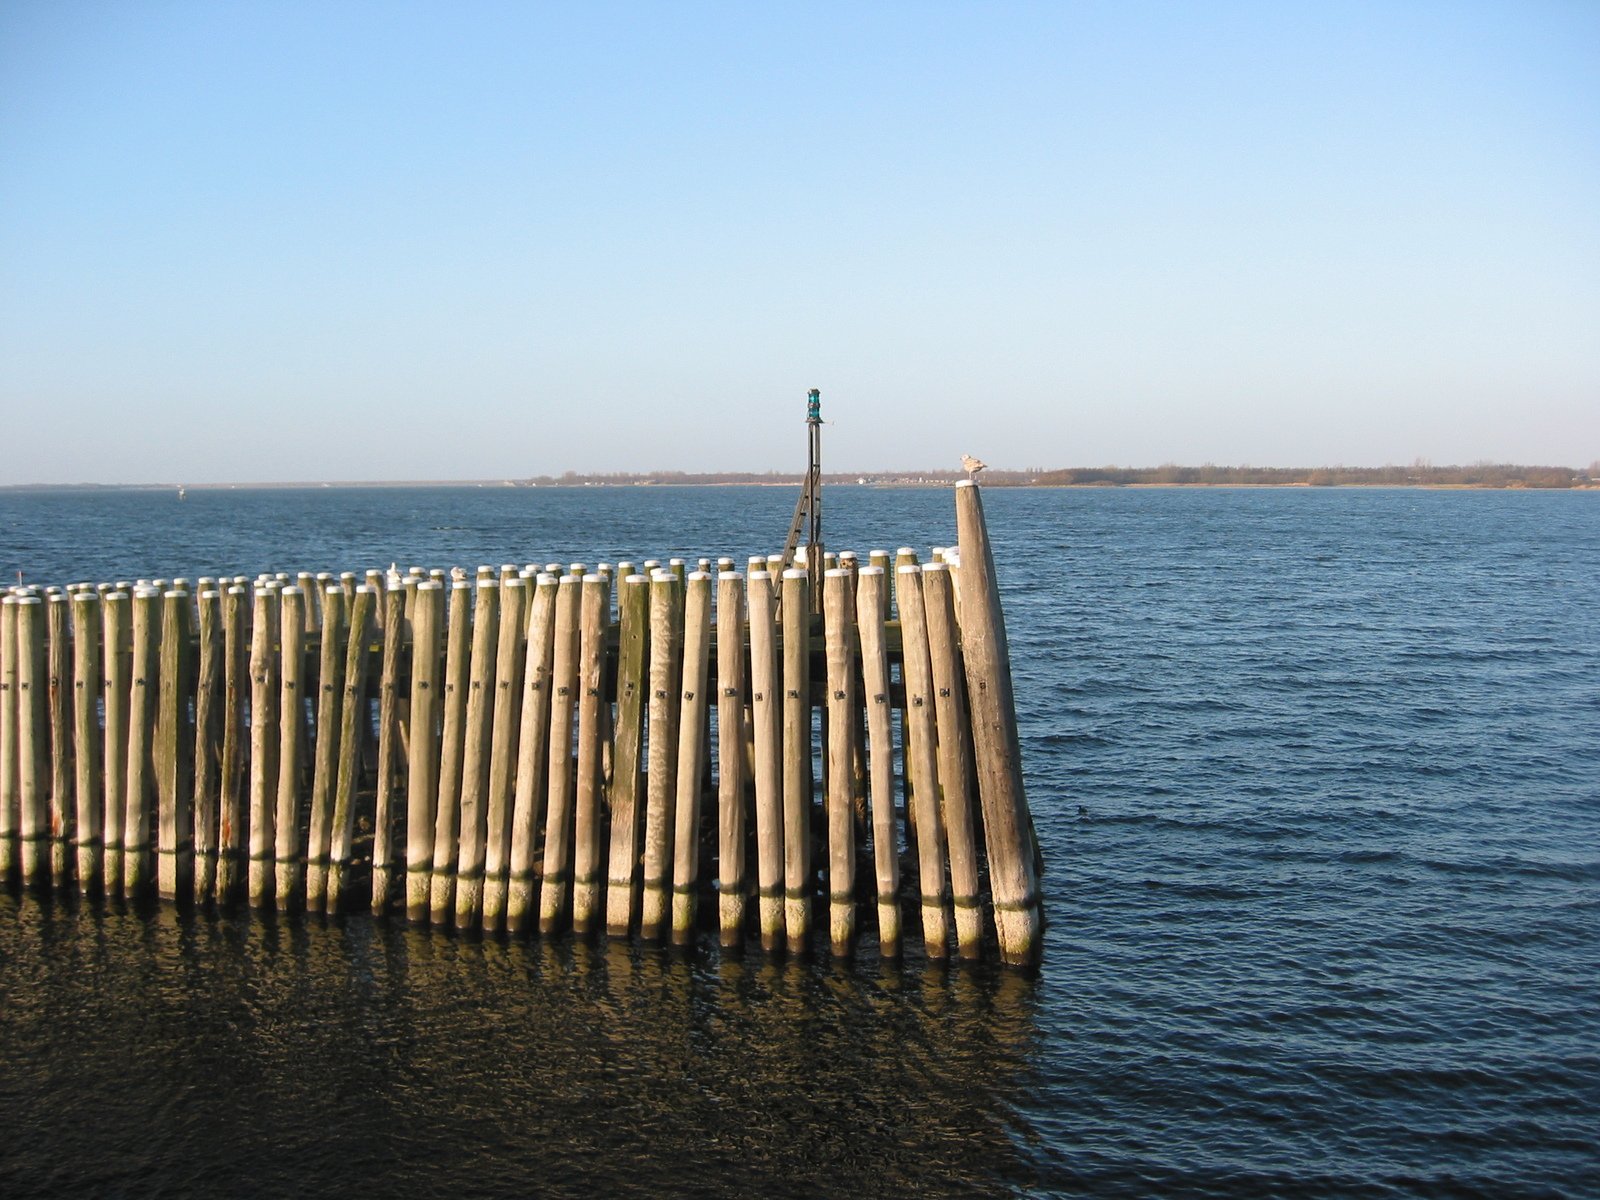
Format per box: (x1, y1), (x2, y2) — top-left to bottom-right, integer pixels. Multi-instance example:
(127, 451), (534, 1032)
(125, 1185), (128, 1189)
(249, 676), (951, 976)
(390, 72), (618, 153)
(922, 563), (984, 958)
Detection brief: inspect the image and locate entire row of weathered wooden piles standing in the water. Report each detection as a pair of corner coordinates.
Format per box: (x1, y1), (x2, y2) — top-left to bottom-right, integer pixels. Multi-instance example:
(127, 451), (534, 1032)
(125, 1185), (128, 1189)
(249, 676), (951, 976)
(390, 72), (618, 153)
(0, 485), (1042, 965)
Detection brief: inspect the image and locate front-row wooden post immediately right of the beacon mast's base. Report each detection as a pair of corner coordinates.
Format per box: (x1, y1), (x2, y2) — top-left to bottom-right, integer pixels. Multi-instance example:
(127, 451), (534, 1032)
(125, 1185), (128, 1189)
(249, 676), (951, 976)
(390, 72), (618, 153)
(822, 566), (856, 955)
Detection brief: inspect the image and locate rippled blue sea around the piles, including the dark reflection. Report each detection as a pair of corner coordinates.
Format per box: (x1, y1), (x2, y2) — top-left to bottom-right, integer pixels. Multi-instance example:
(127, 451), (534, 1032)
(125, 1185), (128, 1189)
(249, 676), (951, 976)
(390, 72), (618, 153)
(0, 488), (1600, 1197)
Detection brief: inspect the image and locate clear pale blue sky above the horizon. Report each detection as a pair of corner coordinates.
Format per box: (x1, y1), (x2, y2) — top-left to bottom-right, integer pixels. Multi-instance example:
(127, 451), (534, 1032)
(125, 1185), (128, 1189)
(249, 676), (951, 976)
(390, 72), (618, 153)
(0, 0), (1600, 483)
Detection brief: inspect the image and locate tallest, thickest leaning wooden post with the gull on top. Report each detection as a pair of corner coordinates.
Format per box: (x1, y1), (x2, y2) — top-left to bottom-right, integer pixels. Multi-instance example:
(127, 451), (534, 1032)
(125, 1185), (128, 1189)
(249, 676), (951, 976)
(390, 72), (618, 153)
(955, 480), (1043, 966)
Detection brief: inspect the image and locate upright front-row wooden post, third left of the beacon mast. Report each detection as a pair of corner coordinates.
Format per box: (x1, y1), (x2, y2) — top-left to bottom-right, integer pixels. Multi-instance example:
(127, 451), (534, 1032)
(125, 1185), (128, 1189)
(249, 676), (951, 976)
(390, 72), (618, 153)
(717, 572), (746, 947)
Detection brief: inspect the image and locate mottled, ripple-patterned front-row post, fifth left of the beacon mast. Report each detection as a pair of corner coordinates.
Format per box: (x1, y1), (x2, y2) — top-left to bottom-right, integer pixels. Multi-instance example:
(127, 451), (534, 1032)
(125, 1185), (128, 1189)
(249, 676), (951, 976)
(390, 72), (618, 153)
(638, 571), (683, 939)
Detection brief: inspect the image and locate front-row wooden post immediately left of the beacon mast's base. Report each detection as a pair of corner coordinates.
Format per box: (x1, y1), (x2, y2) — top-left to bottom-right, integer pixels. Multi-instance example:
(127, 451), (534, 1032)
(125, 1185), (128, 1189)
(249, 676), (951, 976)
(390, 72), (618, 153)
(782, 566), (821, 949)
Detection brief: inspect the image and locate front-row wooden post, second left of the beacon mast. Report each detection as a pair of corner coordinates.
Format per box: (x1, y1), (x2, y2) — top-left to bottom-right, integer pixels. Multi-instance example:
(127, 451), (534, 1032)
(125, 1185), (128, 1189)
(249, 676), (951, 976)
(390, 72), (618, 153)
(746, 571), (780, 950)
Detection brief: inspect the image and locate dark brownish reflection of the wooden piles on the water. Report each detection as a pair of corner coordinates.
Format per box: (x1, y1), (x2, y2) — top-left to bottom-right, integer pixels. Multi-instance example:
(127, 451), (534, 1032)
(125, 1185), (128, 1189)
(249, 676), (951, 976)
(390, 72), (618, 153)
(0, 896), (1037, 1197)
